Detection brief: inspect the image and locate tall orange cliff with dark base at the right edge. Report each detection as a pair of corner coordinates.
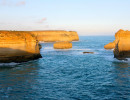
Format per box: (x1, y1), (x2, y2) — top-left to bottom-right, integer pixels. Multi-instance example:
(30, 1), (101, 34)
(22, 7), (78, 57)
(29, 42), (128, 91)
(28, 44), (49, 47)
(114, 30), (130, 59)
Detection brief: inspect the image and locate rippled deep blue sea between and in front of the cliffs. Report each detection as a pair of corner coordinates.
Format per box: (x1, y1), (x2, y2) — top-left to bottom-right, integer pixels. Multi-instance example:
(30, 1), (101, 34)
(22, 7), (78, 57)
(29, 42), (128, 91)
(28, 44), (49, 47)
(0, 36), (130, 100)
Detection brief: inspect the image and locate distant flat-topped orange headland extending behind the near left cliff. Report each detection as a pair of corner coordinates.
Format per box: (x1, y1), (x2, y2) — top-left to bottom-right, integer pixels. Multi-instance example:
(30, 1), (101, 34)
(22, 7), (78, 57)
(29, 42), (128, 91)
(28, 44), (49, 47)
(31, 31), (79, 42)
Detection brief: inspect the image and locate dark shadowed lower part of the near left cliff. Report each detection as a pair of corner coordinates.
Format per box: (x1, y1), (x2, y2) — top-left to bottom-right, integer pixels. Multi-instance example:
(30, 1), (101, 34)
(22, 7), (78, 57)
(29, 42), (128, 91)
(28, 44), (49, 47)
(0, 48), (42, 63)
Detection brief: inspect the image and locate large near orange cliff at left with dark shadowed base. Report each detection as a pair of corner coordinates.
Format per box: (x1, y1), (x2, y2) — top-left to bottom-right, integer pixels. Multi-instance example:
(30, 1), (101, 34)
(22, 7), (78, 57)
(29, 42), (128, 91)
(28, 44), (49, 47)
(0, 31), (41, 63)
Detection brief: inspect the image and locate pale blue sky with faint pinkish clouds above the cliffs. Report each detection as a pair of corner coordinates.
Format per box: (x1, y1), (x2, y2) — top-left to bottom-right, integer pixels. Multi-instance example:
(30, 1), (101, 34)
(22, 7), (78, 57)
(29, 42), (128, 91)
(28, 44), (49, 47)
(0, 0), (130, 36)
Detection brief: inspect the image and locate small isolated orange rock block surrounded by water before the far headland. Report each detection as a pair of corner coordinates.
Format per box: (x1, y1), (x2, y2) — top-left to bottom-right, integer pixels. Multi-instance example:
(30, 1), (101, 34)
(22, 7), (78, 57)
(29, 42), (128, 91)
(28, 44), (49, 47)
(53, 42), (72, 49)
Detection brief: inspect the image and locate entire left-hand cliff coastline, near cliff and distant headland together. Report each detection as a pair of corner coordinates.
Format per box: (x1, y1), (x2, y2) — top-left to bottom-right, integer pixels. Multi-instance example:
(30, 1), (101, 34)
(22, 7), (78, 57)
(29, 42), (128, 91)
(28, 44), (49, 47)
(0, 31), (79, 63)
